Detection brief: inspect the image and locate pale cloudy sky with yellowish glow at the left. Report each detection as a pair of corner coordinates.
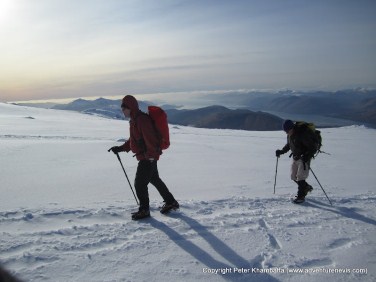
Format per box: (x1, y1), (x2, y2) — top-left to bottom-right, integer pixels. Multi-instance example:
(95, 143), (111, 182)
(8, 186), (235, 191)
(0, 0), (376, 102)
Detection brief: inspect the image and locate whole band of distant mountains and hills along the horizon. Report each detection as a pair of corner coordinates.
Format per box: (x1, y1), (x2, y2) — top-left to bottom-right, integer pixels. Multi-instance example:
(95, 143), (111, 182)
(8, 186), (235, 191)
(14, 89), (376, 130)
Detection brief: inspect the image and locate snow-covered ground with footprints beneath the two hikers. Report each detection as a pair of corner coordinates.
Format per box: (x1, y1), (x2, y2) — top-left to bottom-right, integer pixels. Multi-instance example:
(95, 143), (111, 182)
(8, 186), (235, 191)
(0, 103), (376, 281)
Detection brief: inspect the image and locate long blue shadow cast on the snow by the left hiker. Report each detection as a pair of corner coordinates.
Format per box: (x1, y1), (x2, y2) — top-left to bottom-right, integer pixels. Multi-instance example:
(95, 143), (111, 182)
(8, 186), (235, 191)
(149, 213), (279, 282)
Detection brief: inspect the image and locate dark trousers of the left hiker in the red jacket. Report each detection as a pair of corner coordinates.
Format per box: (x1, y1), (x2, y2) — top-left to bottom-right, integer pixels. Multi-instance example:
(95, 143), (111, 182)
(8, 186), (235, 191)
(134, 160), (175, 210)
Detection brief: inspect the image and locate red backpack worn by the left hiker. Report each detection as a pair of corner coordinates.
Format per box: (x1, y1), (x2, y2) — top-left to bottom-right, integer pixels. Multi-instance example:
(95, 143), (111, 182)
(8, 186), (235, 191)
(148, 106), (170, 150)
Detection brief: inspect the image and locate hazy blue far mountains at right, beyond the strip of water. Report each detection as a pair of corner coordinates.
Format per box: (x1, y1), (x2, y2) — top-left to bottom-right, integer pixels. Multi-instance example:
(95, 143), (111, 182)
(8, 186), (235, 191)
(200, 88), (376, 127)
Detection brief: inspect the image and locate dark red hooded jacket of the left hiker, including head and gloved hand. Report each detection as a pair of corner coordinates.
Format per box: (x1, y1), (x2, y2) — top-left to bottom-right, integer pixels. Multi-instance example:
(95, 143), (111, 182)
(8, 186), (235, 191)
(121, 95), (161, 161)
